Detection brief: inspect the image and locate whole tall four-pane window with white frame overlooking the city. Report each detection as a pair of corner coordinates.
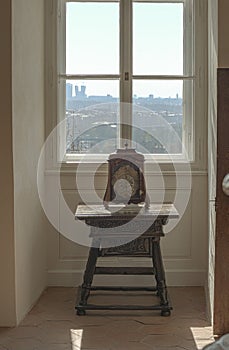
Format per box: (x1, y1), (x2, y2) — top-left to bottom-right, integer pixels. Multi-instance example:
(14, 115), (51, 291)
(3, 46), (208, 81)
(47, 0), (207, 161)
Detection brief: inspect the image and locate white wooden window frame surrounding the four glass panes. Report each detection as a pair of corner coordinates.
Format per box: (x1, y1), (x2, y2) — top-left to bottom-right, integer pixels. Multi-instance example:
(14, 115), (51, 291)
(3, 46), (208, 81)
(46, 0), (207, 169)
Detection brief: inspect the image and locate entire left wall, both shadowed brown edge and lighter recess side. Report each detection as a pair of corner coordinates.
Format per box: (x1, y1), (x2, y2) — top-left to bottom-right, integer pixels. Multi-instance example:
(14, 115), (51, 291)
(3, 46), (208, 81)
(0, 0), (47, 327)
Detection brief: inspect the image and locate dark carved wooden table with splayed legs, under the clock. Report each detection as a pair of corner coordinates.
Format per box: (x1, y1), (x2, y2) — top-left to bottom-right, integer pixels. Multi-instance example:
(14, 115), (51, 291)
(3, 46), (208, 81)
(75, 203), (178, 316)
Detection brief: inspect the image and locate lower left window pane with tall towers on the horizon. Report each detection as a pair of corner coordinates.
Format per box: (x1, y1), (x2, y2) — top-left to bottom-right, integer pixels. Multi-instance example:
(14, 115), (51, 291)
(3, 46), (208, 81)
(66, 80), (119, 154)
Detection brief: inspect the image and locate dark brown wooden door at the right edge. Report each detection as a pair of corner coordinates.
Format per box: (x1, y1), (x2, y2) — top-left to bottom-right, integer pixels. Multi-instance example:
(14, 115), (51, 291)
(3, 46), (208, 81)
(213, 68), (229, 335)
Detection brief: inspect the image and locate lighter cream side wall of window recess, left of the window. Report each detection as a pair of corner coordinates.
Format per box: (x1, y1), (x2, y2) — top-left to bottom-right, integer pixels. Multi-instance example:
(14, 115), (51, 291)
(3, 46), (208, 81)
(12, 0), (46, 322)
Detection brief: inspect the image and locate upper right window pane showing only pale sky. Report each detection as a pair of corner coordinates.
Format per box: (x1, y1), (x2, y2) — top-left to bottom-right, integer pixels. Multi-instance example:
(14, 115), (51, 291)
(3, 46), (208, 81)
(133, 3), (183, 75)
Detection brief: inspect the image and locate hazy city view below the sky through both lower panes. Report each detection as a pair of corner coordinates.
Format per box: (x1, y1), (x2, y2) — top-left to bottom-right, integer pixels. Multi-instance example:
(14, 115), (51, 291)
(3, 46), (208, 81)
(66, 83), (183, 153)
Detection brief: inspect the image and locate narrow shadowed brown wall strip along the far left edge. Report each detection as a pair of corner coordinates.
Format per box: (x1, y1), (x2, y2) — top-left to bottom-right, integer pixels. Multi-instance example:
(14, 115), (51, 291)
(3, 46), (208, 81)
(0, 0), (16, 327)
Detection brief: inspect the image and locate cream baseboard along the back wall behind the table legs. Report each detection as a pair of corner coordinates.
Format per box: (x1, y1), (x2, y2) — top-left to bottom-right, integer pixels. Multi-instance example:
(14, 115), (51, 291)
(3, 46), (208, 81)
(48, 270), (206, 287)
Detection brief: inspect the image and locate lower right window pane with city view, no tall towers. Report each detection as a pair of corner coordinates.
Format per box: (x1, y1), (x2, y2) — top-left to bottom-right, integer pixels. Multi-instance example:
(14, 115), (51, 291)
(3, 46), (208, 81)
(133, 80), (184, 154)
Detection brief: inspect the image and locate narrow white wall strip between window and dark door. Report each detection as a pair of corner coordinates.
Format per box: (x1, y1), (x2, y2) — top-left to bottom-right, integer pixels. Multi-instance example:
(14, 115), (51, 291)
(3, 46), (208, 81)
(207, 0), (218, 321)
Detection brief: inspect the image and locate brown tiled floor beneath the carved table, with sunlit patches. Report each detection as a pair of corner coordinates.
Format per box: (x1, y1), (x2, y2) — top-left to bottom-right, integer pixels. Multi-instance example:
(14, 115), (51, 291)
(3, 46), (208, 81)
(0, 287), (213, 350)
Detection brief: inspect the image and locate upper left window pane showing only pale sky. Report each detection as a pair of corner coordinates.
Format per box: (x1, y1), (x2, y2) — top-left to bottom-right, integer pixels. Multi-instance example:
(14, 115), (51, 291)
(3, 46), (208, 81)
(66, 2), (119, 74)
